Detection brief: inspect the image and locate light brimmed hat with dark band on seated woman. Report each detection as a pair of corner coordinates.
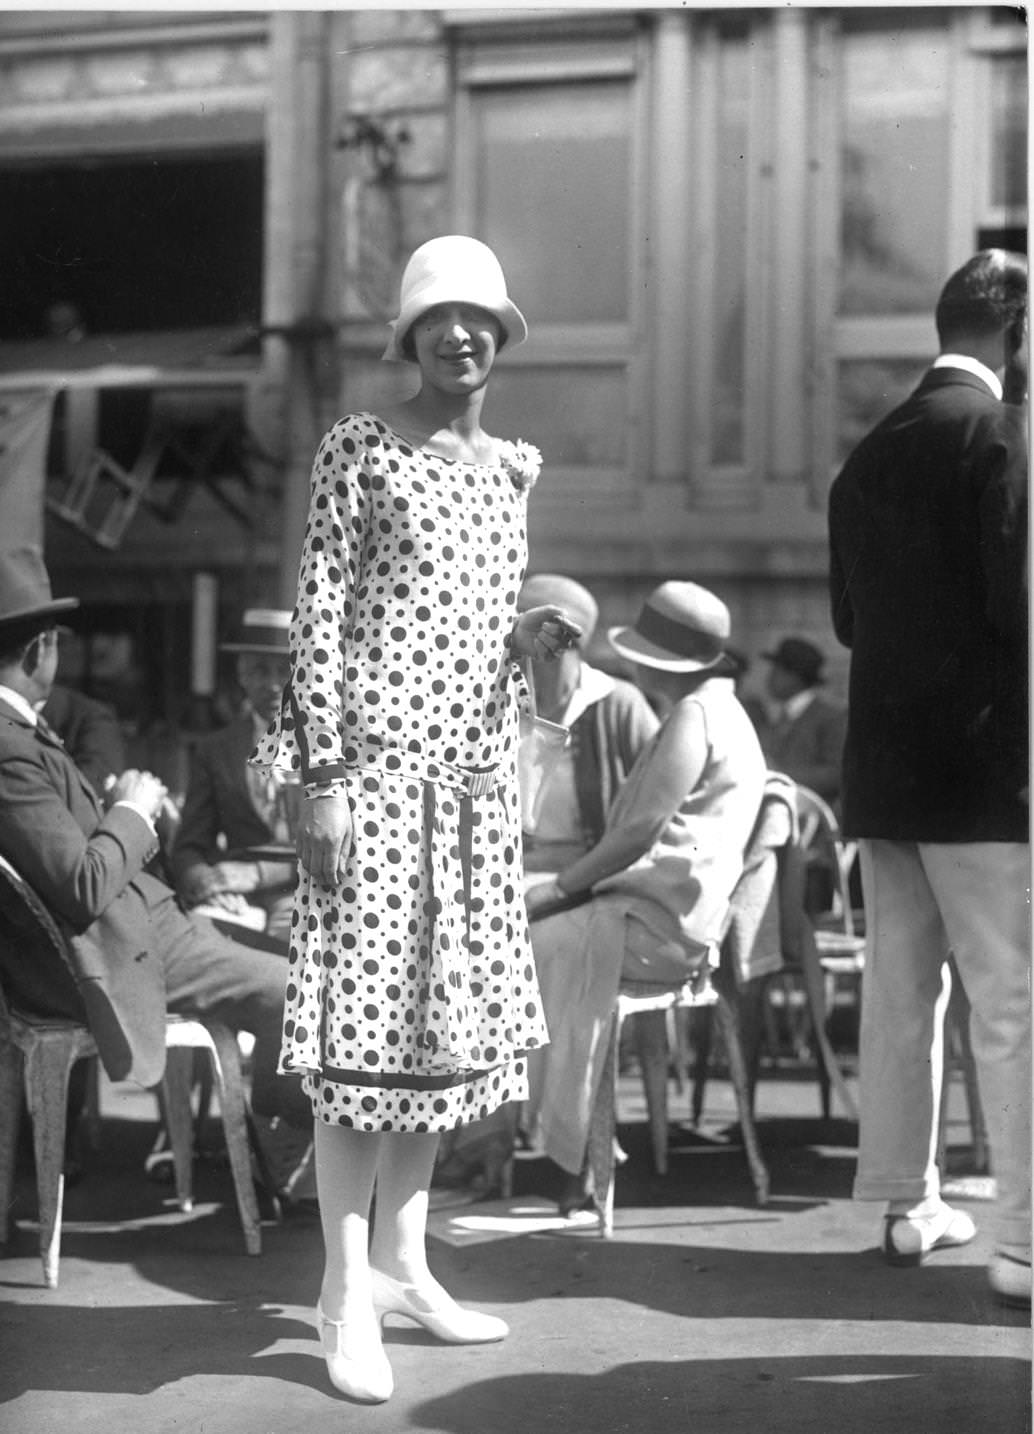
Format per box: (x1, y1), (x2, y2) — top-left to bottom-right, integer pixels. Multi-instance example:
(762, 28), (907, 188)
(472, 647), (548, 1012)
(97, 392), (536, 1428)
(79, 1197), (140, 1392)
(607, 582), (731, 673)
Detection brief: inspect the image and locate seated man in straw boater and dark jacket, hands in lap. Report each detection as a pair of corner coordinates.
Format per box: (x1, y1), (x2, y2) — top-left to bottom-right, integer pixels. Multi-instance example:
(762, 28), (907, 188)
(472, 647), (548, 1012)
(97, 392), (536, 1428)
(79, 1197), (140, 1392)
(171, 608), (295, 949)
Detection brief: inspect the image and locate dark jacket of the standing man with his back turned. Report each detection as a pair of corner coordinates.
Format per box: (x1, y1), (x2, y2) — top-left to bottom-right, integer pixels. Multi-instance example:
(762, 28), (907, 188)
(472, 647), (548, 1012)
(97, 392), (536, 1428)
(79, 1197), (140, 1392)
(829, 369), (1028, 842)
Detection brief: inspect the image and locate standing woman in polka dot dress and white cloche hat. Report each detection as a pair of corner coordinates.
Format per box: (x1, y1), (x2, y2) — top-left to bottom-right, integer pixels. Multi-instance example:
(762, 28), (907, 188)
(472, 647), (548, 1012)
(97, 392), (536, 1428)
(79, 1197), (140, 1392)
(254, 235), (572, 1402)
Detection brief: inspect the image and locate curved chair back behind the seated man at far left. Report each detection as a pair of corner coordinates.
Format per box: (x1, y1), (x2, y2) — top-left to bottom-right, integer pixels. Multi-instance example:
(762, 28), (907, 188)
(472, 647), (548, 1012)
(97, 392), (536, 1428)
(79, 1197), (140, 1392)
(0, 856), (86, 1021)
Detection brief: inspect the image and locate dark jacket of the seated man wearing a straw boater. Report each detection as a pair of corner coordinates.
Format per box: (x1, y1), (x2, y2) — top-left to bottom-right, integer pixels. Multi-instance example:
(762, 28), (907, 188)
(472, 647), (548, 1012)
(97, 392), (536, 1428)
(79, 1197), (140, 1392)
(171, 717), (294, 889)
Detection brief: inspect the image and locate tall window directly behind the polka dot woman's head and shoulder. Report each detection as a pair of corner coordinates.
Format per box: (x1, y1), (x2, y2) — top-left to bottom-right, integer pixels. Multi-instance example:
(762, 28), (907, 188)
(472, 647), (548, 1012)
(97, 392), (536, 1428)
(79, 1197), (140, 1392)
(457, 29), (642, 503)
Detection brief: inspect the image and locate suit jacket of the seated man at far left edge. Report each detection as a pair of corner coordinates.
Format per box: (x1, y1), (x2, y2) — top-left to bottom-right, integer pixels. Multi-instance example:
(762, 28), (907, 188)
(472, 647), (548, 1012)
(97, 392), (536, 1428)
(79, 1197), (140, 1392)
(0, 700), (167, 1086)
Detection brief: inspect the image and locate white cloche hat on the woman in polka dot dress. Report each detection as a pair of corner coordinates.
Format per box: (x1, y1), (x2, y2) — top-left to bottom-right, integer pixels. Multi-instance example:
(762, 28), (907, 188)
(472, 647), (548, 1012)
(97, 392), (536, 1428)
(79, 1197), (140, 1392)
(381, 234), (528, 361)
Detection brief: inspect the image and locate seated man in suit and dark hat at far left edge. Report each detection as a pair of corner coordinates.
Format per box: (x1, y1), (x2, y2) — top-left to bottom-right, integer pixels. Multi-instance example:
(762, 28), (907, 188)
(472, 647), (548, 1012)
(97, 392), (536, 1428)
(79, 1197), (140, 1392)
(0, 548), (313, 1210)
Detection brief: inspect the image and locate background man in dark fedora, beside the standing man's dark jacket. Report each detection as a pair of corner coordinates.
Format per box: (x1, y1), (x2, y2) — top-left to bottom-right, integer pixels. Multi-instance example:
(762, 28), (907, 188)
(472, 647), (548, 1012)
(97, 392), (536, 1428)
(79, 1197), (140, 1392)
(759, 637), (848, 804)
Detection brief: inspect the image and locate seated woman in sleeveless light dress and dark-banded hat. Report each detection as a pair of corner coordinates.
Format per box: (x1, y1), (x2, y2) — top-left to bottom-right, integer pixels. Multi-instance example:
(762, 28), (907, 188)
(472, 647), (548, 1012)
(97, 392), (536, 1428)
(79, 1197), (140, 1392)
(526, 582), (766, 1198)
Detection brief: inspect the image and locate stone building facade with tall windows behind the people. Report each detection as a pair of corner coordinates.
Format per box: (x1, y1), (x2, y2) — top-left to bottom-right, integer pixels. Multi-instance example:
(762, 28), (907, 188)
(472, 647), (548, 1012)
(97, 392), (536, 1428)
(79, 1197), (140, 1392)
(0, 6), (1027, 751)
